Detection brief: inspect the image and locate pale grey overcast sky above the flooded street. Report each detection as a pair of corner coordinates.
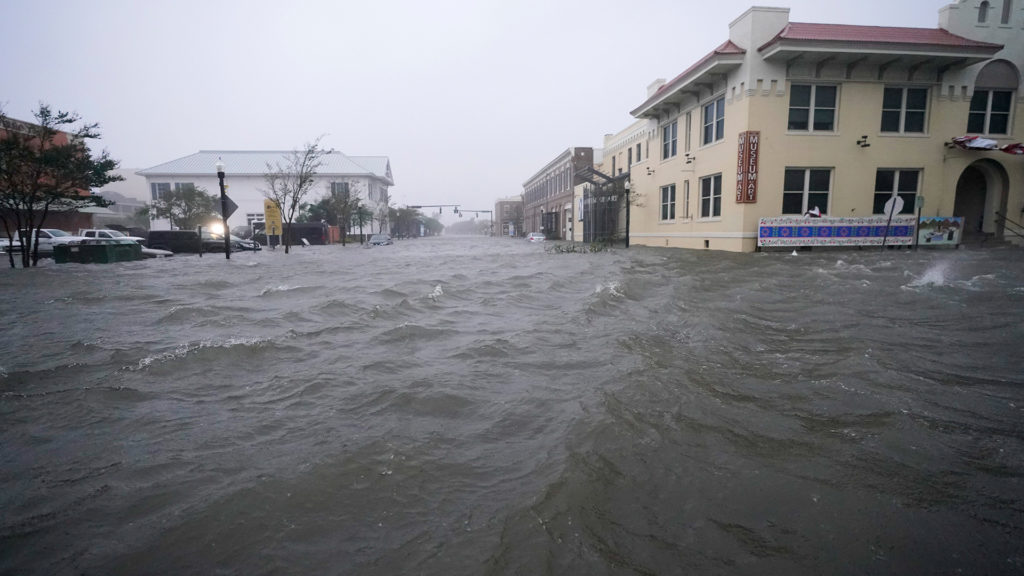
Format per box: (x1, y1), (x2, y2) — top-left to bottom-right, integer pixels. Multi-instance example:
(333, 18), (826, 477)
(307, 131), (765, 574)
(0, 0), (951, 217)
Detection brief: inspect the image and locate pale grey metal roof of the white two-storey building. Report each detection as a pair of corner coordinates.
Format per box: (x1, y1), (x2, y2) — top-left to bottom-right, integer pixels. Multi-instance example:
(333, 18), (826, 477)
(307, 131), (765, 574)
(135, 150), (394, 184)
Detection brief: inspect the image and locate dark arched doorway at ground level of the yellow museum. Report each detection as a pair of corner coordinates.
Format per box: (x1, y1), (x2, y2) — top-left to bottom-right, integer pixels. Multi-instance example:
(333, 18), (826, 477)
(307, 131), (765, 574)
(953, 159), (1010, 242)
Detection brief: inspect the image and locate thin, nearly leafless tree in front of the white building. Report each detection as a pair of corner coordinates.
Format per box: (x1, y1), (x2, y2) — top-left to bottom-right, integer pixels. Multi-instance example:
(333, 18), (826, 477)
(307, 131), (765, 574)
(262, 136), (331, 254)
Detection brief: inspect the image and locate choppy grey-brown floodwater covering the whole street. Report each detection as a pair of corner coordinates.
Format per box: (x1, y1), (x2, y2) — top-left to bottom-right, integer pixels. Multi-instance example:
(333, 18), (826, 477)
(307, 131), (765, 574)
(0, 238), (1024, 575)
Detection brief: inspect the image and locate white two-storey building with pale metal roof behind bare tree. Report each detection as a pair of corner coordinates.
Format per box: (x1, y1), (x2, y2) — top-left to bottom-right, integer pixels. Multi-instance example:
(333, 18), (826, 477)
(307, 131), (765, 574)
(137, 150), (394, 232)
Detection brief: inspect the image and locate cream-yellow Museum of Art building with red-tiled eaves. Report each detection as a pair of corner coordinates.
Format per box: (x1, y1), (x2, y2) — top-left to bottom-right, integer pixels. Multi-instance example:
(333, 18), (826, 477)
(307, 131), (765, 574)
(618, 0), (1024, 251)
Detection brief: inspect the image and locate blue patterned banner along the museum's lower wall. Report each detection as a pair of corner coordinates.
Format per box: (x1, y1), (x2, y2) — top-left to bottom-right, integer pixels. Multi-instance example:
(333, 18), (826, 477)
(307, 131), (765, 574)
(758, 215), (918, 247)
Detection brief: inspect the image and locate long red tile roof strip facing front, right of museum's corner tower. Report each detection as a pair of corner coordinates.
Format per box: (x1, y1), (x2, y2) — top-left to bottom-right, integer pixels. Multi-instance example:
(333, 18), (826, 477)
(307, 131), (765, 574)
(758, 22), (1001, 50)
